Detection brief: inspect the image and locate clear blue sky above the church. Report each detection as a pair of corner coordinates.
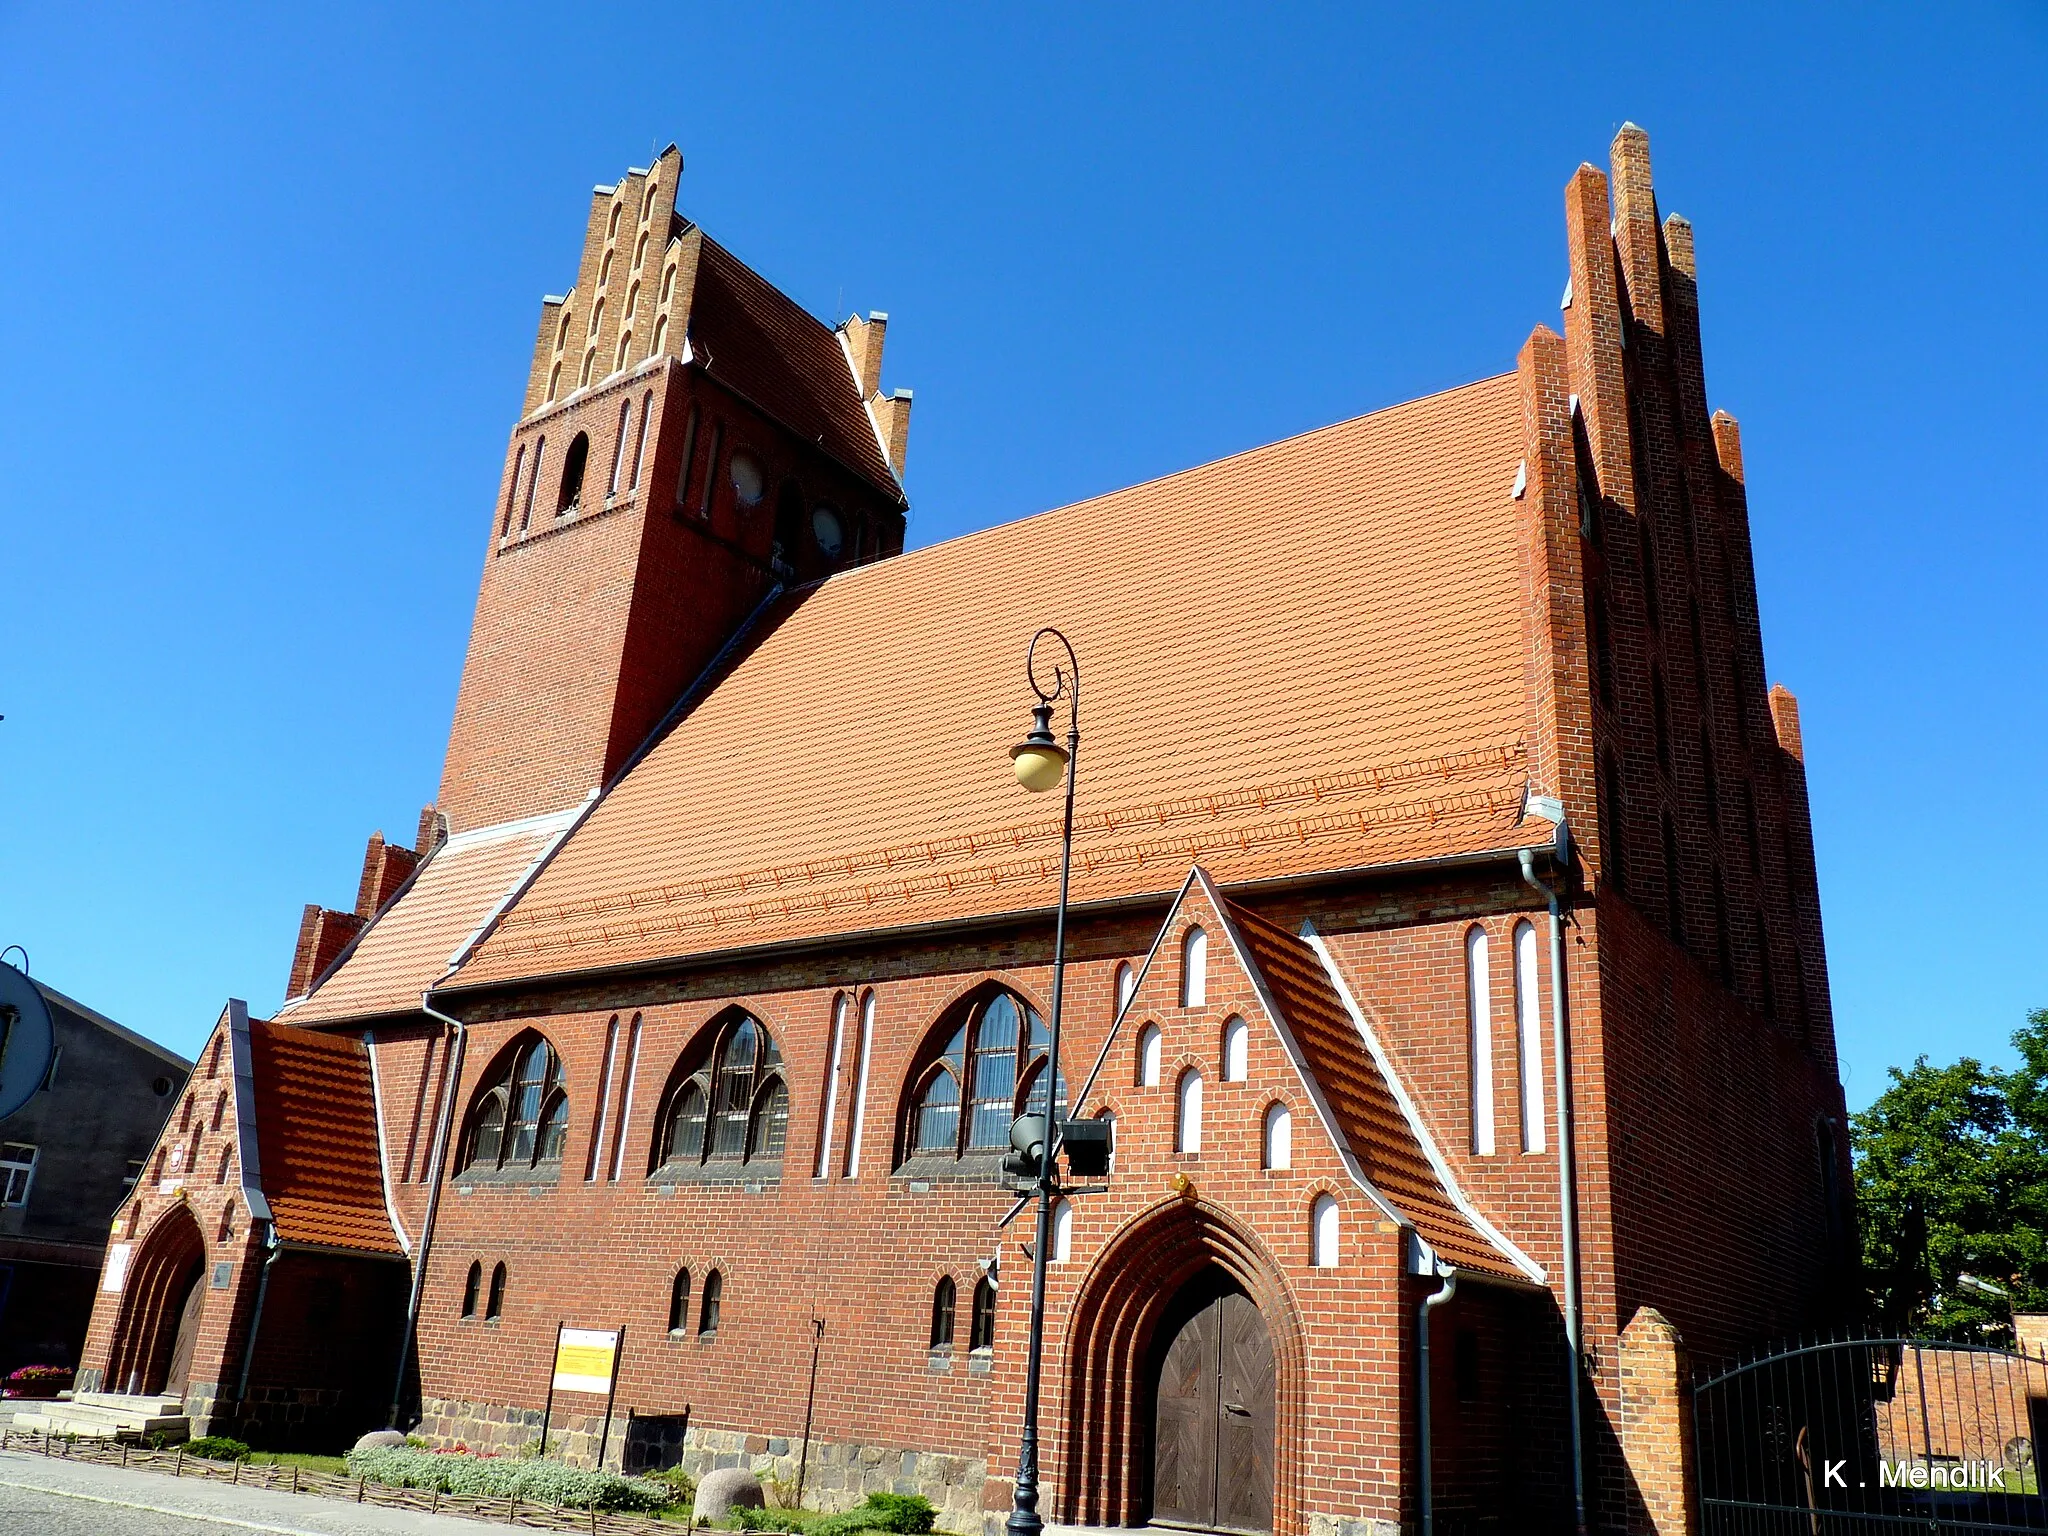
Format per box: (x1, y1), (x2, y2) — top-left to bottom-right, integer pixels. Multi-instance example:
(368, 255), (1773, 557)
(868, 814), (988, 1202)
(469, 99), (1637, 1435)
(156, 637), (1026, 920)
(0, 4), (2048, 1104)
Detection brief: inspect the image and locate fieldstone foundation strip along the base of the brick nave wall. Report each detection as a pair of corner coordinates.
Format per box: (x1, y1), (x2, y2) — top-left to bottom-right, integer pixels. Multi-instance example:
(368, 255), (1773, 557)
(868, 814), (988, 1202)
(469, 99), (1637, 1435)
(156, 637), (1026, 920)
(414, 1397), (983, 1536)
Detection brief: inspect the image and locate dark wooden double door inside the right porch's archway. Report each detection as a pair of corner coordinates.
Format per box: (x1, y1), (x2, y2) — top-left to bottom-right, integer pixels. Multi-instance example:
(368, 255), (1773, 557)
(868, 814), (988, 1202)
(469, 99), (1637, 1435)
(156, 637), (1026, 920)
(1153, 1290), (1274, 1532)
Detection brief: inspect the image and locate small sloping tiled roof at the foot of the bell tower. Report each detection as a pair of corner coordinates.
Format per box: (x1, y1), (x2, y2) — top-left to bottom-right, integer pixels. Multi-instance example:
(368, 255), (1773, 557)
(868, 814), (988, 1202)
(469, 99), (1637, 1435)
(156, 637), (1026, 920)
(279, 811), (575, 1024)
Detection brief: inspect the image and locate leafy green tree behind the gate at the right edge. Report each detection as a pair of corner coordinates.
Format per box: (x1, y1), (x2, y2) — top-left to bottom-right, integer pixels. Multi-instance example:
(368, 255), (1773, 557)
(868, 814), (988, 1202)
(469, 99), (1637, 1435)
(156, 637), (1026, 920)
(1849, 1008), (2048, 1339)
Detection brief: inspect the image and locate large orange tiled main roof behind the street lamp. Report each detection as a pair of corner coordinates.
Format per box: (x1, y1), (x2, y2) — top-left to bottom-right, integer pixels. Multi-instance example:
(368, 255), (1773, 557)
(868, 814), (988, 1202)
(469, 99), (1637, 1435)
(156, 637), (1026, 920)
(455, 375), (1526, 985)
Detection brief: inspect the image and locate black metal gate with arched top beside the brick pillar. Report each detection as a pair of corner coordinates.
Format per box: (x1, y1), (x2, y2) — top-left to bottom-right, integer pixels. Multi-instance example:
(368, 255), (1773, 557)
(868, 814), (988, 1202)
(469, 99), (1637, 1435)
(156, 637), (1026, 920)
(1692, 1339), (2048, 1536)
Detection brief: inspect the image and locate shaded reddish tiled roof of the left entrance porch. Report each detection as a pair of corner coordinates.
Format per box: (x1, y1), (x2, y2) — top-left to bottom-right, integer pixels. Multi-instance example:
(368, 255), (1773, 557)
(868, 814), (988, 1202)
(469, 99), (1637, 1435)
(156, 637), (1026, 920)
(250, 1018), (401, 1253)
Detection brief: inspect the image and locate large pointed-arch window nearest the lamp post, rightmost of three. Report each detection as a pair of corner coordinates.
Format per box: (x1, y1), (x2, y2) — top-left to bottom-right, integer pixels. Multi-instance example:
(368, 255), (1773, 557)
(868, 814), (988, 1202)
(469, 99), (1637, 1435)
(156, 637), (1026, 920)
(905, 991), (1067, 1157)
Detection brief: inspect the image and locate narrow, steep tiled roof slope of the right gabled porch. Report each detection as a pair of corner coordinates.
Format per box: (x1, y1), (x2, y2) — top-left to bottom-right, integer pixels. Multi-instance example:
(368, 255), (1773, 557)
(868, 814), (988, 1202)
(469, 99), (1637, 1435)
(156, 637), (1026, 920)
(1223, 901), (1530, 1282)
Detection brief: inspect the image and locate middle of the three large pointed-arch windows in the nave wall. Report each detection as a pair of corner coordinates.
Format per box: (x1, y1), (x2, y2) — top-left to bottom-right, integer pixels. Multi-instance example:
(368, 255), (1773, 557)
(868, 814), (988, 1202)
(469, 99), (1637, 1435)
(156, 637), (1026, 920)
(649, 1012), (788, 1171)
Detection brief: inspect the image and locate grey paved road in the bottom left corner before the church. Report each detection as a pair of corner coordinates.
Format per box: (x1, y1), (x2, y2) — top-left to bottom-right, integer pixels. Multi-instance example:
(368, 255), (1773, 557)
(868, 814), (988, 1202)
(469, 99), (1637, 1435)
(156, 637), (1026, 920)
(0, 1450), (489, 1536)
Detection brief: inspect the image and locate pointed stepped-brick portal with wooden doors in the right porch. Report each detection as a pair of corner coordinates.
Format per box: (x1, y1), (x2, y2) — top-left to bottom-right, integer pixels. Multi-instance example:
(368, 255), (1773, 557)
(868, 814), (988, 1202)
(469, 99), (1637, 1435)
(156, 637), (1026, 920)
(1059, 1200), (1307, 1530)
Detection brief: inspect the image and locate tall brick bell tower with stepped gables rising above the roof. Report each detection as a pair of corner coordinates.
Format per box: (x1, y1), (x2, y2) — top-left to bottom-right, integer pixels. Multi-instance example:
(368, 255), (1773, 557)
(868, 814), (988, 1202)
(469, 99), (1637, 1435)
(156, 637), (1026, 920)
(440, 145), (911, 834)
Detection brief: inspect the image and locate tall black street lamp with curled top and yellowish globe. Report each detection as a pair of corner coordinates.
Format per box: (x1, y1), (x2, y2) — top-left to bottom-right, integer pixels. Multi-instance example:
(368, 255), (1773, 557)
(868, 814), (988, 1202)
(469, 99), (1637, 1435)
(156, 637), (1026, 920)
(1008, 629), (1081, 1536)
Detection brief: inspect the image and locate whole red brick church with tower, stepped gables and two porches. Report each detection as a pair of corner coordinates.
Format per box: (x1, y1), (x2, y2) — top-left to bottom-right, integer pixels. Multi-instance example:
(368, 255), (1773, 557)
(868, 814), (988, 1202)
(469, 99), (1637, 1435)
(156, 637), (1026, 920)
(82, 127), (1853, 1536)
